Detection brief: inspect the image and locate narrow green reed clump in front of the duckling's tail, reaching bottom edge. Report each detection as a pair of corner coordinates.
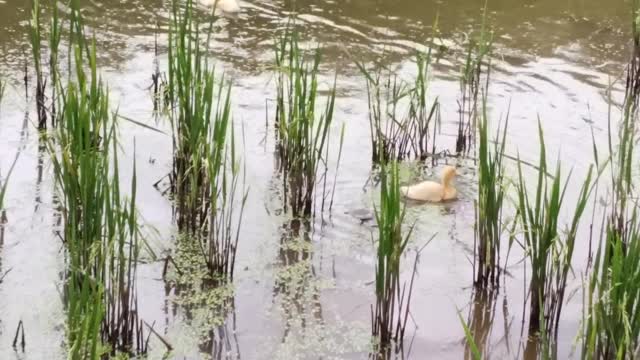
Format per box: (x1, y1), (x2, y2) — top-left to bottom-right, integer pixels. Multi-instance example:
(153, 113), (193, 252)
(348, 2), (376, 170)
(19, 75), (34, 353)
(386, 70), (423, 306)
(371, 162), (417, 356)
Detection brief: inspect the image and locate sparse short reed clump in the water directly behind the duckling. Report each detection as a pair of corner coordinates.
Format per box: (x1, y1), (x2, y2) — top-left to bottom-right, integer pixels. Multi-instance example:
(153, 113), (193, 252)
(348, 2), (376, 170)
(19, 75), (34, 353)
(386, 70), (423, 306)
(356, 47), (440, 164)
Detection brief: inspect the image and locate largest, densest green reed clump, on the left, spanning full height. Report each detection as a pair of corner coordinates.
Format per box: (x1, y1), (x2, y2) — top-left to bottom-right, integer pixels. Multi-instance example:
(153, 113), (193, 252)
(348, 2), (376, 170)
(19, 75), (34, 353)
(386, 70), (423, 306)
(49, 1), (146, 359)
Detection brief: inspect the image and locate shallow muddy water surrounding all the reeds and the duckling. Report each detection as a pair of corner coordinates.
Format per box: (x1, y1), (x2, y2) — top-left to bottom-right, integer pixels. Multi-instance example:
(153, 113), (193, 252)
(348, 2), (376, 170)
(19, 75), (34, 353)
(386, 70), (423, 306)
(0, 0), (640, 359)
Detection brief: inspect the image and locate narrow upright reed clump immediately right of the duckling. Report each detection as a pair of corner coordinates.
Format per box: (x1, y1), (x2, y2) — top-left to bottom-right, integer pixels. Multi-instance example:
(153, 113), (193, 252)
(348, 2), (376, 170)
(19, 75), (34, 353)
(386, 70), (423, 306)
(474, 97), (509, 289)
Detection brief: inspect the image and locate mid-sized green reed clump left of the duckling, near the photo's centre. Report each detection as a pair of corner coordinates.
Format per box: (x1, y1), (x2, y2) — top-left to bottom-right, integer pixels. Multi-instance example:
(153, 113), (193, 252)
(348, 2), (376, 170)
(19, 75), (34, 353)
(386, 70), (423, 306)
(275, 23), (342, 217)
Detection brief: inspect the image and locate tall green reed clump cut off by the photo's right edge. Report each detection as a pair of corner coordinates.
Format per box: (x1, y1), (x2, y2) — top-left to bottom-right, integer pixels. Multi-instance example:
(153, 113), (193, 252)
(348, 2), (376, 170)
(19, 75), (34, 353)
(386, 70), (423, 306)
(582, 1), (640, 359)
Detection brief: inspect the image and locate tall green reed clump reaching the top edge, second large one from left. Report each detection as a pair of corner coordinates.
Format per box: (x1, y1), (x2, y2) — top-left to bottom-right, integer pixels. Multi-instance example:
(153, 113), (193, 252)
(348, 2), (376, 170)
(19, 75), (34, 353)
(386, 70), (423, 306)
(168, 1), (247, 280)
